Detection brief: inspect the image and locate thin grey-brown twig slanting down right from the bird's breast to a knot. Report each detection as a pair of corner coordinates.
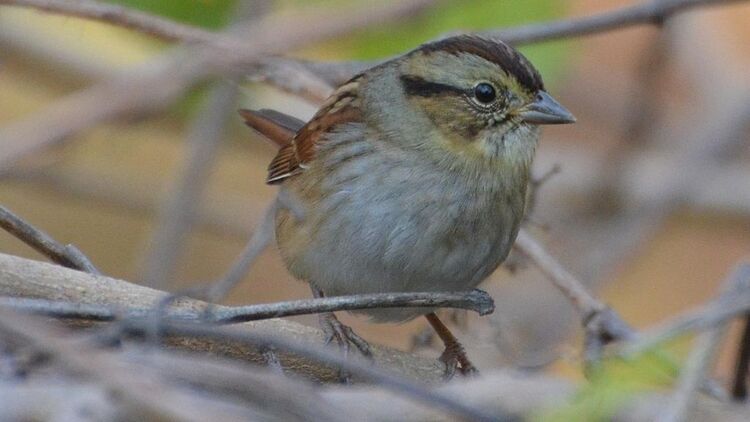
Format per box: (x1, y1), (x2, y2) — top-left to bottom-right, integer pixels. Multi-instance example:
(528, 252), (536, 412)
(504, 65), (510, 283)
(515, 229), (635, 362)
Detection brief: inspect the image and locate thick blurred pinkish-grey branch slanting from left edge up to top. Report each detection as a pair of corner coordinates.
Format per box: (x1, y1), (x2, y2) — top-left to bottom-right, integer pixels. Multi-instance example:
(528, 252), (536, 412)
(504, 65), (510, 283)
(0, 0), (435, 172)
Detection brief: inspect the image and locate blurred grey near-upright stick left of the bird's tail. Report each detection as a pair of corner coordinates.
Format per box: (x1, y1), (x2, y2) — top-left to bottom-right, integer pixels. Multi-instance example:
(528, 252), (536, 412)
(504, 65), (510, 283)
(142, 82), (238, 288)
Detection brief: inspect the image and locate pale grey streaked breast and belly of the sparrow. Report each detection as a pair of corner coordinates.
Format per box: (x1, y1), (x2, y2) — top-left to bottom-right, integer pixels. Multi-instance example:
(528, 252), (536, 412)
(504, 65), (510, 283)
(277, 129), (525, 320)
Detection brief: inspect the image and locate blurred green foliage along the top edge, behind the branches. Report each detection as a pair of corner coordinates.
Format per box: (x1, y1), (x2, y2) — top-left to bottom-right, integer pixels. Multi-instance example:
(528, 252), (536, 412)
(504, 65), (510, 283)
(108, 0), (568, 80)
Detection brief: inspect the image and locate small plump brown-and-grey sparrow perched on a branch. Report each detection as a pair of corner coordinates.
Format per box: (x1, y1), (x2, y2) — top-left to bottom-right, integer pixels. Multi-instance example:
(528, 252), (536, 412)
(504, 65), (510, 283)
(240, 34), (575, 376)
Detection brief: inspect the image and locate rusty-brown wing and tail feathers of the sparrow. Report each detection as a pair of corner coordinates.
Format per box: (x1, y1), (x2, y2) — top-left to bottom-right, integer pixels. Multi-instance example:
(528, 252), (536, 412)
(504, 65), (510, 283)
(240, 78), (361, 184)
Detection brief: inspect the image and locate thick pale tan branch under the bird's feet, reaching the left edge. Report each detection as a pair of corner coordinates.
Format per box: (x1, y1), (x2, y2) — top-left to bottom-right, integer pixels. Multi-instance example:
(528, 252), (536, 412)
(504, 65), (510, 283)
(0, 254), (452, 382)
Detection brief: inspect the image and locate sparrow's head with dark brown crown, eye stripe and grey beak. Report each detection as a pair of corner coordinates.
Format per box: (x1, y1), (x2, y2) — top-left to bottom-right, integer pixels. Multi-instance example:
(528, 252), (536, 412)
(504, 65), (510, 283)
(364, 35), (575, 169)
